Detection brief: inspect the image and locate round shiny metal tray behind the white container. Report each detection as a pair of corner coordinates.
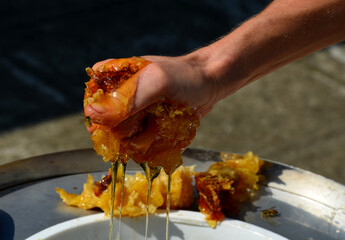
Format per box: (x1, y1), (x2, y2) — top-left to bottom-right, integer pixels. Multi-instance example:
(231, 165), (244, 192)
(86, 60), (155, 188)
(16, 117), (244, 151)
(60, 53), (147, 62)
(0, 149), (345, 240)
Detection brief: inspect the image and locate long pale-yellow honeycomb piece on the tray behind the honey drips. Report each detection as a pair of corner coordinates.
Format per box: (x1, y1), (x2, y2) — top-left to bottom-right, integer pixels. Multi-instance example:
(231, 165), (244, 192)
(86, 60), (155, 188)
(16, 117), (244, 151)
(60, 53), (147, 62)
(56, 166), (194, 217)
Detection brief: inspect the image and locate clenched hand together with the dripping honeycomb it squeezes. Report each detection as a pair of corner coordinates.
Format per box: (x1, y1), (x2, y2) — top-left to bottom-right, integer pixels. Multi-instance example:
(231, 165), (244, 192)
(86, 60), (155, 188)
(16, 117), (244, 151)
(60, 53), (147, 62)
(84, 56), (211, 169)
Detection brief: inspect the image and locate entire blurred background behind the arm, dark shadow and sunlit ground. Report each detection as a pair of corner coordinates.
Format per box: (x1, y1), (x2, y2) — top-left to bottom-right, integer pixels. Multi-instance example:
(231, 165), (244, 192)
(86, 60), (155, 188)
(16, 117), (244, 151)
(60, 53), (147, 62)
(0, 0), (345, 184)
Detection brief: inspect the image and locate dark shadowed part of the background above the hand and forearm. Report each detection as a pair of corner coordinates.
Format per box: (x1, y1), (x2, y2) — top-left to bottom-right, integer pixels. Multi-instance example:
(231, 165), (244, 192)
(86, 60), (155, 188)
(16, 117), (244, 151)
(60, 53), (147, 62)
(0, 0), (270, 131)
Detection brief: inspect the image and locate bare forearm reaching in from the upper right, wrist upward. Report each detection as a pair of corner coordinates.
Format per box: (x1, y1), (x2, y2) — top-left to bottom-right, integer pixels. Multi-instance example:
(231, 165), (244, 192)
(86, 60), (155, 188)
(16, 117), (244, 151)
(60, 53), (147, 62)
(191, 0), (345, 100)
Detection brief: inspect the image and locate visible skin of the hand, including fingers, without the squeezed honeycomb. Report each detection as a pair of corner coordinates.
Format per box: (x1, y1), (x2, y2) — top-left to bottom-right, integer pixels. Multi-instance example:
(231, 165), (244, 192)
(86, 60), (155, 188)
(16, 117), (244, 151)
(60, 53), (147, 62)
(85, 55), (216, 131)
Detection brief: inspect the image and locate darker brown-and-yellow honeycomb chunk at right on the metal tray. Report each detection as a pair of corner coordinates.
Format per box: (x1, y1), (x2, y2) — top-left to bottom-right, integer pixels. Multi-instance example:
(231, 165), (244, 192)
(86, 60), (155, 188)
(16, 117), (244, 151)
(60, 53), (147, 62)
(195, 152), (264, 227)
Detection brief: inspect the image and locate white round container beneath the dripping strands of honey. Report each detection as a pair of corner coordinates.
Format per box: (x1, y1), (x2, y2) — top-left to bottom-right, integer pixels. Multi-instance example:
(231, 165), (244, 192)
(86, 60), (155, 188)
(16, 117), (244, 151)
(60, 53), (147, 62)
(27, 210), (287, 240)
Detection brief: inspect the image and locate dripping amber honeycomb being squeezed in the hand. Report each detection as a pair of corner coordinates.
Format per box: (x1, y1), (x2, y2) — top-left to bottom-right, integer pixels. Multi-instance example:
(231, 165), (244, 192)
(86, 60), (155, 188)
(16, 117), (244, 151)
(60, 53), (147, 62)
(84, 57), (200, 174)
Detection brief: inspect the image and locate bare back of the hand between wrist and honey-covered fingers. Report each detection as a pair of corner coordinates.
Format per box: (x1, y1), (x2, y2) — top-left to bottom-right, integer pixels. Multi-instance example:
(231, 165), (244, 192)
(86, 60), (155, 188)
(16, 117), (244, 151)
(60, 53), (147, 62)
(134, 55), (217, 117)
